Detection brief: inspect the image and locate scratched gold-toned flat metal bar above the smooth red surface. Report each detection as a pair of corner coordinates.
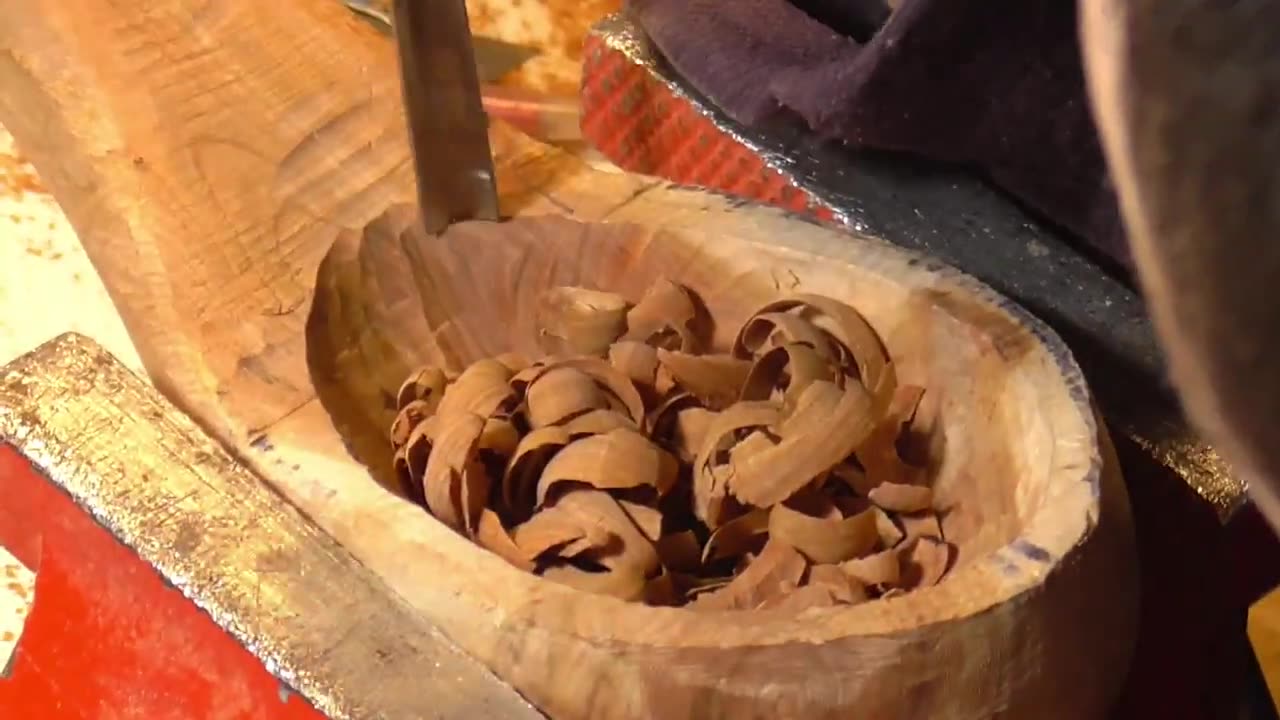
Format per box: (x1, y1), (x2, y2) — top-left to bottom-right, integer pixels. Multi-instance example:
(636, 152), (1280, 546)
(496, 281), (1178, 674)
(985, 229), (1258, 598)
(0, 333), (540, 720)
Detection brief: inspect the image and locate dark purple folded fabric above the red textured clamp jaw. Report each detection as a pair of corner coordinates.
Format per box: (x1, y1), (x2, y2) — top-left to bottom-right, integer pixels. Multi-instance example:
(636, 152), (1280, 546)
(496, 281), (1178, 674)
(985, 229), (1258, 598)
(628, 0), (1129, 265)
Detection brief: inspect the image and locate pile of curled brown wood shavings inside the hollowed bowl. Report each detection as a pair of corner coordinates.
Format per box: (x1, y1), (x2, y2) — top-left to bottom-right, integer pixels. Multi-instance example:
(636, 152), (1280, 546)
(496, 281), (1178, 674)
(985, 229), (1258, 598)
(390, 281), (954, 610)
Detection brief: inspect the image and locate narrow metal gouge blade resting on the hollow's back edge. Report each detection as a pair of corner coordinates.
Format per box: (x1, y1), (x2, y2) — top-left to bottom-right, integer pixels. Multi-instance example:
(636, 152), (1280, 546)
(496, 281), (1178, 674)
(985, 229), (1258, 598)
(392, 0), (498, 234)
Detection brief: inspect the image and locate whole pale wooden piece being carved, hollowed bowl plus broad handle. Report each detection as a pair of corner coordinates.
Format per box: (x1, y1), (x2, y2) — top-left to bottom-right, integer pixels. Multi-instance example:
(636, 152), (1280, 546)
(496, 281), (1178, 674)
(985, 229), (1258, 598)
(0, 0), (1137, 720)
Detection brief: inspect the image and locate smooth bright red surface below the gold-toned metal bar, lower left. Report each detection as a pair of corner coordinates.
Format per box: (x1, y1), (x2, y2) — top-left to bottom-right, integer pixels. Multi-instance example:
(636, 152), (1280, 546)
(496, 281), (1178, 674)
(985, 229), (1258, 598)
(0, 445), (323, 720)
